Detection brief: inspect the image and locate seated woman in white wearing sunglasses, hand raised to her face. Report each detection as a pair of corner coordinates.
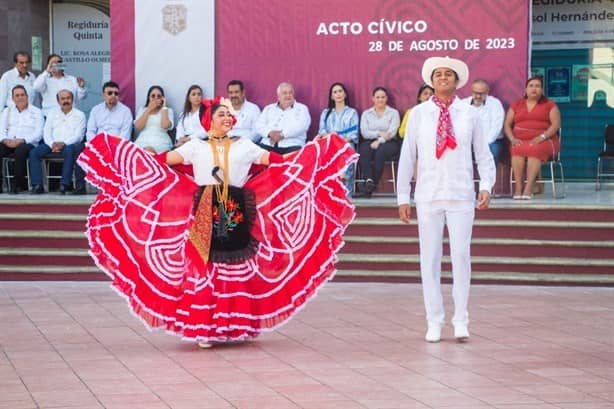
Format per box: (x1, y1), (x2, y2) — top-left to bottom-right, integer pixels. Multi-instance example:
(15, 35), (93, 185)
(134, 85), (174, 153)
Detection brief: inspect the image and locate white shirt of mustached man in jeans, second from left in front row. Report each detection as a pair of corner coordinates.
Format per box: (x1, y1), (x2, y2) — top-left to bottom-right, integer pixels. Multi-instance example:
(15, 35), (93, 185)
(43, 108), (85, 147)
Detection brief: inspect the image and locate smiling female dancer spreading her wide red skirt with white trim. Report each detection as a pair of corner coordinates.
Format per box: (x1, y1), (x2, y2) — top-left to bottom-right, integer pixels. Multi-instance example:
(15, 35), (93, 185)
(79, 97), (356, 347)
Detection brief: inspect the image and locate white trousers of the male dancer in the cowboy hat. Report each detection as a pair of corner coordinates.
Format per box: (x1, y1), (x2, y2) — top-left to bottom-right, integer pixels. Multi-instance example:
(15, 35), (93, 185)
(416, 200), (475, 325)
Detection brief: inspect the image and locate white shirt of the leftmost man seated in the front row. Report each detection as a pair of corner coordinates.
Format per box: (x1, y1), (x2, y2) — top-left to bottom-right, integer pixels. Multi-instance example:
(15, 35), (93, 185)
(0, 105), (45, 146)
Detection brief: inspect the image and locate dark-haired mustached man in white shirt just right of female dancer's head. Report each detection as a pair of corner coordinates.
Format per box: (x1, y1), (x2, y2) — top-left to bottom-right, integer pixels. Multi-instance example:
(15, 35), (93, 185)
(226, 80), (260, 143)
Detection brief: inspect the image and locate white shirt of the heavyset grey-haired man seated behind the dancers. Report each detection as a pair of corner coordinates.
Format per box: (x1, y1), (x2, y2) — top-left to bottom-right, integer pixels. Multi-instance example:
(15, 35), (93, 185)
(256, 102), (311, 148)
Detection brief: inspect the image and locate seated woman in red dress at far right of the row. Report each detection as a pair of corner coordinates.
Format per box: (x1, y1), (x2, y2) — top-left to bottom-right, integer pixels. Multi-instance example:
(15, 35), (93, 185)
(503, 77), (561, 200)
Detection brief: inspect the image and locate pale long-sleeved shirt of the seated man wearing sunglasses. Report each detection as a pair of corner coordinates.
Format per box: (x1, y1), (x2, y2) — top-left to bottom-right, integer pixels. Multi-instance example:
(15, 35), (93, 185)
(85, 102), (133, 141)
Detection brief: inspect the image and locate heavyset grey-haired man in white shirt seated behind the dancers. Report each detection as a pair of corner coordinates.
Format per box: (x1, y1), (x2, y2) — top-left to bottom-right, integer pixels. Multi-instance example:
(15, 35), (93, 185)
(256, 82), (311, 155)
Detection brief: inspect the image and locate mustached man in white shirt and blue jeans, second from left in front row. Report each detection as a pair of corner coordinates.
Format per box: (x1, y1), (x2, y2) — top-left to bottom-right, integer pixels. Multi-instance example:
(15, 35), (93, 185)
(29, 89), (85, 194)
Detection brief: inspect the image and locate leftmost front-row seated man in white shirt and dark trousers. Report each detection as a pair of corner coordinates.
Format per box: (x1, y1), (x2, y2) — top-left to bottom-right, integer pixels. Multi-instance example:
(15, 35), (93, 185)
(0, 85), (44, 194)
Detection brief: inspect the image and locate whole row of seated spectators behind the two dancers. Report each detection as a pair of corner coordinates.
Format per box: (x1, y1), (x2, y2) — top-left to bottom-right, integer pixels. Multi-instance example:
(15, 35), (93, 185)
(0, 51), (560, 199)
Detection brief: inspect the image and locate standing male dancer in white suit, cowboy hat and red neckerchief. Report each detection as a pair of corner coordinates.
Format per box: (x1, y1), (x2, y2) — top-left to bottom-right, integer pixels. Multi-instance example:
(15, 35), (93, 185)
(397, 57), (495, 342)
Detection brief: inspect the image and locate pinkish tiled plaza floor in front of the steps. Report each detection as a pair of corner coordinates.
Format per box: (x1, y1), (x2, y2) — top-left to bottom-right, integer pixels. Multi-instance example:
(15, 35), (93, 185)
(0, 282), (614, 409)
